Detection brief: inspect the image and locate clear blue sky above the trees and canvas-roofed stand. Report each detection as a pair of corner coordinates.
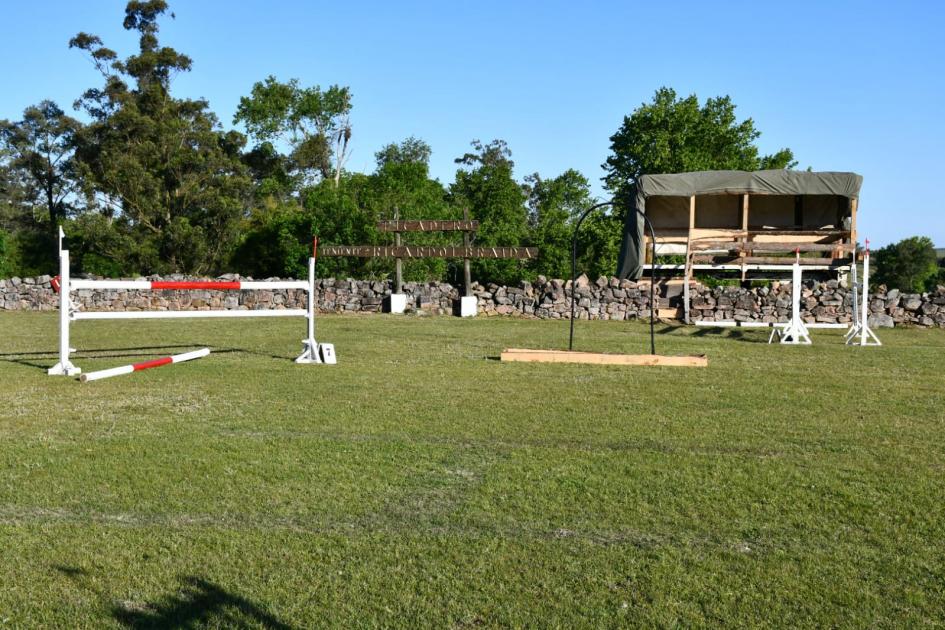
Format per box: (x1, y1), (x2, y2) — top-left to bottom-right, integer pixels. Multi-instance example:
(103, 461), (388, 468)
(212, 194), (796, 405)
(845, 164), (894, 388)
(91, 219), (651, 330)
(0, 0), (945, 247)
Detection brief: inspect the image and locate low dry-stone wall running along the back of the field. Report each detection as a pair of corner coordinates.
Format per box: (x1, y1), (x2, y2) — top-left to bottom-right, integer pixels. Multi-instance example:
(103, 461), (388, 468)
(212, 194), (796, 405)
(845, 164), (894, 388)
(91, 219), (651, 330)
(0, 275), (945, 328)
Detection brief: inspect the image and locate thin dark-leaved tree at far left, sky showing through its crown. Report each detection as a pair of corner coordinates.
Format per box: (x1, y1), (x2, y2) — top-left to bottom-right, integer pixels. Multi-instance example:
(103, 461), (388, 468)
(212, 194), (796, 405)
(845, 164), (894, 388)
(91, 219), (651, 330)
(0, 100), (81, 234)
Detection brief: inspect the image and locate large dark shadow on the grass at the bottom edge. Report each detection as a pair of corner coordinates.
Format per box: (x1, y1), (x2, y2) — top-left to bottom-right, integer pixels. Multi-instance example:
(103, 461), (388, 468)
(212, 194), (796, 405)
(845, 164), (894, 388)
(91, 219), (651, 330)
(112, 576), (292, 630)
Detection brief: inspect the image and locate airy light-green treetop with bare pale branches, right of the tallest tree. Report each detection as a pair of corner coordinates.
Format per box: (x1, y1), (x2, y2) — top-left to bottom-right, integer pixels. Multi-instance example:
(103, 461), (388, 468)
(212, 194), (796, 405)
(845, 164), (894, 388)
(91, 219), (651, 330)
(233, 76), (351, 187)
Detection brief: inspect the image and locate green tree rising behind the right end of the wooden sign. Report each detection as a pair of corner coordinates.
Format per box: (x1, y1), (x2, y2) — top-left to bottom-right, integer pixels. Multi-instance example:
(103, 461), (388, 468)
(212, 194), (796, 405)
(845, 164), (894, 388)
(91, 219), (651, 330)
(450, 140), (528, 283)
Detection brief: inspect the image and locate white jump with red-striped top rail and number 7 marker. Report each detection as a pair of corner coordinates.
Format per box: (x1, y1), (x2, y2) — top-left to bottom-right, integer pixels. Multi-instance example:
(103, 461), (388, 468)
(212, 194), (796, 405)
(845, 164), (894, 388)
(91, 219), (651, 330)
(48, 239), (336, 376)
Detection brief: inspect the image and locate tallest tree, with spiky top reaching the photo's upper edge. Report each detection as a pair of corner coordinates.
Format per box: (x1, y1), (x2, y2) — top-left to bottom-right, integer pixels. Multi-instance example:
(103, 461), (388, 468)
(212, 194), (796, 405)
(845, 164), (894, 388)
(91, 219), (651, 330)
(69, 0), (250, 273)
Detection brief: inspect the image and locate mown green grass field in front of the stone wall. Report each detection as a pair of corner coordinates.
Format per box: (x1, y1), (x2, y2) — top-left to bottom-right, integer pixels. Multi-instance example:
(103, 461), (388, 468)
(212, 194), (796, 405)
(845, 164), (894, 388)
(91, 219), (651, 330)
(0, 313), (945, 628)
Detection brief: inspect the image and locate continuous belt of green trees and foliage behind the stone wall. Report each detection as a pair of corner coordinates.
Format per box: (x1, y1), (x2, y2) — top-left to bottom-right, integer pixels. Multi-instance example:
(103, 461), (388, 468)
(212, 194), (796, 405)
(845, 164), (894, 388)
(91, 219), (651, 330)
(12, 0), (916, 283)
